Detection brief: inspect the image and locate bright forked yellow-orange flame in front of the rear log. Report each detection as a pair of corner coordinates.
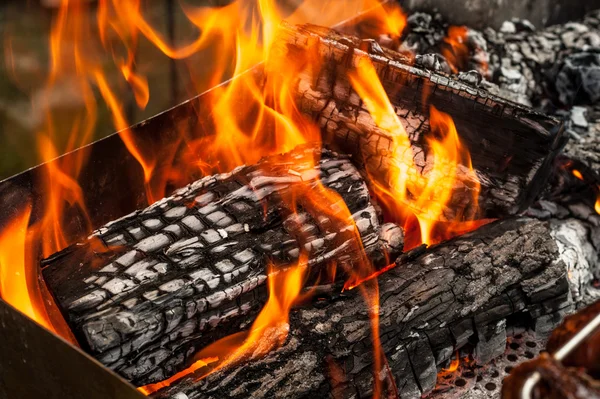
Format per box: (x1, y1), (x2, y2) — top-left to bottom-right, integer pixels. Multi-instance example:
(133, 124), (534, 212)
(349, 57), (480, 247)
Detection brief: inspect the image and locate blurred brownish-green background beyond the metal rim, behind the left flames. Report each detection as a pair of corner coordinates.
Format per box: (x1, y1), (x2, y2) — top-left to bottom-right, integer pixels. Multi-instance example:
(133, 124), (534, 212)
(0, 0), (244, 180)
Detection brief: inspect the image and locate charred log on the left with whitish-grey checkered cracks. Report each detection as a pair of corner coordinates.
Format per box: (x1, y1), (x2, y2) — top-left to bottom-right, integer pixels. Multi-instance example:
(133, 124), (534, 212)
(42, 147), (403, 385)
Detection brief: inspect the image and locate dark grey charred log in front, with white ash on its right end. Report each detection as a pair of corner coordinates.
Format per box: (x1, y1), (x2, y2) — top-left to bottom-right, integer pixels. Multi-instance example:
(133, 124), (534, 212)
(155, 218), (587, 399)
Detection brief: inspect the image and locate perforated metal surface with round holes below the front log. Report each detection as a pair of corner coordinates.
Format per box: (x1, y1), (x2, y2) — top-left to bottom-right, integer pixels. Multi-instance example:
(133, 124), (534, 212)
(429, 331), (546, 399)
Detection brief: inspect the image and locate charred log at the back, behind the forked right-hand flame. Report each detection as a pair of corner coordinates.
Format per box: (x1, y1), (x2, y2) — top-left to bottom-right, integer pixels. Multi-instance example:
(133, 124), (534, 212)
(278, 25), (565, 225)
